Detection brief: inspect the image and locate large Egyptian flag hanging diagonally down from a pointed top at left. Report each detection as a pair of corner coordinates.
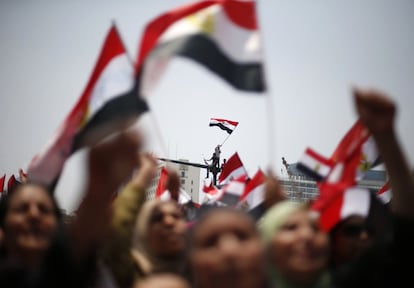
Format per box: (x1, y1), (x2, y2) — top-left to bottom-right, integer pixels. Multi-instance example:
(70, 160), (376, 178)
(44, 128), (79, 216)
(27, 25), (148, 185)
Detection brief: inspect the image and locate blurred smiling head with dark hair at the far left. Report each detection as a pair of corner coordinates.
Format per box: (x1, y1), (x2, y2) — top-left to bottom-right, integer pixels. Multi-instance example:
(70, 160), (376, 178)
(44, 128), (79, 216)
(0, 182), (61, 264)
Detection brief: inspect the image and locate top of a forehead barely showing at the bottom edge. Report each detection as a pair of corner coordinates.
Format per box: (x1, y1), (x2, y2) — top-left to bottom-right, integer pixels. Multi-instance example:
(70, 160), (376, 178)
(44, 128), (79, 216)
(133, 273), (190, 288)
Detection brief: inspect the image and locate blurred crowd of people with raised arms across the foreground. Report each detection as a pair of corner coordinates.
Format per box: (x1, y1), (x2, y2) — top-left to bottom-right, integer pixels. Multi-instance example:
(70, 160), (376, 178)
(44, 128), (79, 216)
(0, 89), (414, 288)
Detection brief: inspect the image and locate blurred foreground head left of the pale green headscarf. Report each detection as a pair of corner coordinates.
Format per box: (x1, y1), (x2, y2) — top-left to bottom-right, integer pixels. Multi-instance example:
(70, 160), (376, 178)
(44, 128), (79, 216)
(189, 207), (265, 288)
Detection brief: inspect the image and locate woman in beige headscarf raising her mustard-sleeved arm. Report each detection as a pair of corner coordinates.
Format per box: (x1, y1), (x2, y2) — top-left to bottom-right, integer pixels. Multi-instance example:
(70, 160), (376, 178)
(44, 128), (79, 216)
(102, 154), (186, 288)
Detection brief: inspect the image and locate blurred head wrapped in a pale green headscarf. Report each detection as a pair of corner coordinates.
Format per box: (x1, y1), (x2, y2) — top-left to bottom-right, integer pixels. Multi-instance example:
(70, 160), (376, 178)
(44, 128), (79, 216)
(259, 200), (329, 284)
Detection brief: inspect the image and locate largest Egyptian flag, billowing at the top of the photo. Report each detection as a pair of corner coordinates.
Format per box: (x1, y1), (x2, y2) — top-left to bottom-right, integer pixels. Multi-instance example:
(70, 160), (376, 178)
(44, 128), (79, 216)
(136, 0), (266, 96)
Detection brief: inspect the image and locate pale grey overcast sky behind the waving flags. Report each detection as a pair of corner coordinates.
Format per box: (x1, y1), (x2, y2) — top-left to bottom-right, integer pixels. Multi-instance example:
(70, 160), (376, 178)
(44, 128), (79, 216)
(0, 0), (414, 211)
